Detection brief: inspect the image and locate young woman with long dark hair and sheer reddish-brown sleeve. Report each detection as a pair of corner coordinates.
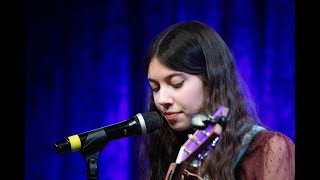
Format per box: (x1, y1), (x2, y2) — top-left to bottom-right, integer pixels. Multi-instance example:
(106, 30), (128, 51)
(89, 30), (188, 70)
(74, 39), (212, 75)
(140, 21), (295, 180)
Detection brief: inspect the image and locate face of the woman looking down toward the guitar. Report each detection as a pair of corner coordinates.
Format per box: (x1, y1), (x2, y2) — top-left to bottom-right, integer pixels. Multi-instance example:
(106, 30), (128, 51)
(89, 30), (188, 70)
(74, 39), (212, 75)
(148, 58), (207, 131)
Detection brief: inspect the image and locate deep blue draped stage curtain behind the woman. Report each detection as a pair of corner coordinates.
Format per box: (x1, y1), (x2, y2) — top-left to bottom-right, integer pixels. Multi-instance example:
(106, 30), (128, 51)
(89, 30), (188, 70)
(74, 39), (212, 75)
(24, 0), (295, 180)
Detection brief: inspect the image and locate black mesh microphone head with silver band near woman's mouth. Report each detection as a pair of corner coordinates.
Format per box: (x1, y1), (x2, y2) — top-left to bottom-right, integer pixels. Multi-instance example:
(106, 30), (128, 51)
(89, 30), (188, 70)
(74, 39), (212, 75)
(137, 111), (161, 135)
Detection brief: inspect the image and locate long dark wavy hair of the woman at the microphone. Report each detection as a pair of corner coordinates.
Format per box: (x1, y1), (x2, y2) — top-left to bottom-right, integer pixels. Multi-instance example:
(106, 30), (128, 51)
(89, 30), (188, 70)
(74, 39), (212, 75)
(140, 21), (260, 180)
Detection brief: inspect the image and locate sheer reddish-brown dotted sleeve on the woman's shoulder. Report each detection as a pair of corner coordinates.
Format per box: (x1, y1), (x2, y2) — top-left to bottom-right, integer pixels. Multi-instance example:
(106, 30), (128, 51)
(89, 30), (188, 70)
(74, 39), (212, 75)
(236, 131), (295, 179)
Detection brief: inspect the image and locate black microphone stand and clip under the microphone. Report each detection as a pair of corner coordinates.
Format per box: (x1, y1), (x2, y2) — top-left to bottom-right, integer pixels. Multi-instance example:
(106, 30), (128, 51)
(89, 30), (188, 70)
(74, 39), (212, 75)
(80, 130), (108, 180)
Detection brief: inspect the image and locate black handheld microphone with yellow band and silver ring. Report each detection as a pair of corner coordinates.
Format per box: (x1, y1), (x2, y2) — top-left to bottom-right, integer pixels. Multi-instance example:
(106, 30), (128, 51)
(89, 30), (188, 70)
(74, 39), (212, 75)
(54, 111), (160, 154)
